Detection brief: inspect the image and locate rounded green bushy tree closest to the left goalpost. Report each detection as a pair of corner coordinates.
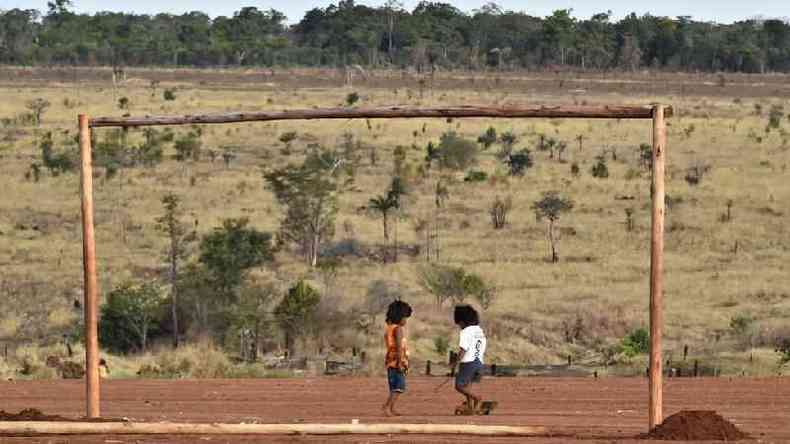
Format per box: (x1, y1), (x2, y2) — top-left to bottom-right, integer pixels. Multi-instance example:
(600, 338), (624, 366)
(99, 282), (163, 353)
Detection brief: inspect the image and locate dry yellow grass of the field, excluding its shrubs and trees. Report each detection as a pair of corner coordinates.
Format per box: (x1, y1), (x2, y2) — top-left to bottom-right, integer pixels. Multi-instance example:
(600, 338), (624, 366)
(0, 68), (790, 375)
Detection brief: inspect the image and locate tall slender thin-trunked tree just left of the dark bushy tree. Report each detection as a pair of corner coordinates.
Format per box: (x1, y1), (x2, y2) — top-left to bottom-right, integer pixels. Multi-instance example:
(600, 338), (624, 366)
(156, 193), (196, 348)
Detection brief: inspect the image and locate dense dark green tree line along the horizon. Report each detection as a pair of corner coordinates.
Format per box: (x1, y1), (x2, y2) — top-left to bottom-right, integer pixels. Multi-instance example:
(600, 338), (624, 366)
(0, 0), (790, 73)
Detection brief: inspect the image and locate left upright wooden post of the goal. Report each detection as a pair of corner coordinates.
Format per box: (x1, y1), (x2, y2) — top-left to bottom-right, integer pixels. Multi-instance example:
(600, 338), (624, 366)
(79, 114), (100, 418)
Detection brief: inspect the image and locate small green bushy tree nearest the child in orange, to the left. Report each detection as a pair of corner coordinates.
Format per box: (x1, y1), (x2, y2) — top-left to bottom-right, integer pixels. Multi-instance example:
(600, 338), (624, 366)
(274, 280), (321, 356)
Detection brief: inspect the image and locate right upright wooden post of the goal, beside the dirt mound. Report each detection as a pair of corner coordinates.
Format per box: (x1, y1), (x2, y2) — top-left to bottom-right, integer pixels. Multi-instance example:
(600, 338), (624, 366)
(648, 105), (667, 430)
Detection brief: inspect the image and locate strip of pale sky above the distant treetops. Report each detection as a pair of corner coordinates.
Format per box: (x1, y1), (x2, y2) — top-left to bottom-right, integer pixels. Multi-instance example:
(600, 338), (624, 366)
(0, 0), (790, 23)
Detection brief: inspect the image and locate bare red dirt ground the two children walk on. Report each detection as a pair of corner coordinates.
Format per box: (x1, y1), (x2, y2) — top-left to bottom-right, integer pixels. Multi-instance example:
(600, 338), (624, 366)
(0, 377), (790, 444)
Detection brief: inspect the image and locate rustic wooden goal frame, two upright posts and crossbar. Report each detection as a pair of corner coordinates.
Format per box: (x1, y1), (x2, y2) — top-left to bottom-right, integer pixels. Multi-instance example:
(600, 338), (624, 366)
(74, 104), (673, 430)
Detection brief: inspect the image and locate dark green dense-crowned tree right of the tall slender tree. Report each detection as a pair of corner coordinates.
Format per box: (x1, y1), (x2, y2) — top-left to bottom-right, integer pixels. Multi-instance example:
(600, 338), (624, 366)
(199, 218), (274, 301)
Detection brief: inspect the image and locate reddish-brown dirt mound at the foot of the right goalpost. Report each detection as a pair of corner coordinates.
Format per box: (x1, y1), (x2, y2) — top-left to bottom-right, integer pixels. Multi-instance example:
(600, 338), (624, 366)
(644, 410), (749, 441)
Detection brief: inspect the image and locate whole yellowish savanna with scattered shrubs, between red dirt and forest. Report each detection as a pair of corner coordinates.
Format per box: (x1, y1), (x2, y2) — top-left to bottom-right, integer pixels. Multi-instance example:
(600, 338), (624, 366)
(0, 41), (790, 377)
